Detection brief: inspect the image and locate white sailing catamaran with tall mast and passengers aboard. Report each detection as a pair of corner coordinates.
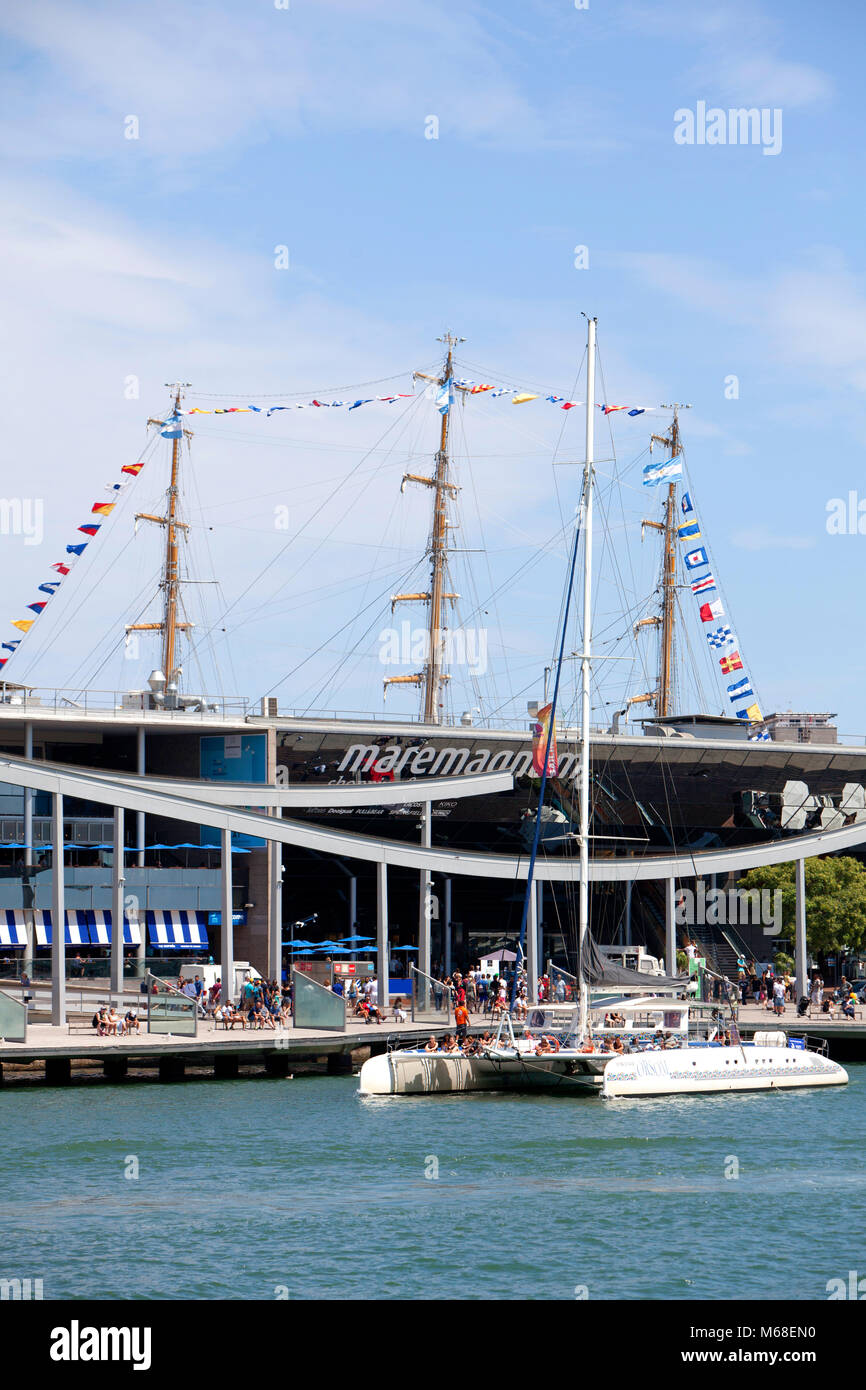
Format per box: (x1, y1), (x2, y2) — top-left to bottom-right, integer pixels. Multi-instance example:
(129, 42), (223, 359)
(359, 318), (848, 1098)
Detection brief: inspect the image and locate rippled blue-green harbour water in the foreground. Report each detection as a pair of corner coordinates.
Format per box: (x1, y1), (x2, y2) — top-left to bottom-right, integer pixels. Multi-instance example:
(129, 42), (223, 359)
(0, 1065), (866, 1300)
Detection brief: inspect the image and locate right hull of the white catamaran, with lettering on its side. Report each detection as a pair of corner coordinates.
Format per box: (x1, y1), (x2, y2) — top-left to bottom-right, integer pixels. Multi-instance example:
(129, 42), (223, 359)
(602, 1045), (848, 1099)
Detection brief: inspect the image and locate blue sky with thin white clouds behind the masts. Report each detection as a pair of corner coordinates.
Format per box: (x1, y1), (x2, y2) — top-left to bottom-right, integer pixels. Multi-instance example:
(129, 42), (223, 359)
(0, 0), (866, 739)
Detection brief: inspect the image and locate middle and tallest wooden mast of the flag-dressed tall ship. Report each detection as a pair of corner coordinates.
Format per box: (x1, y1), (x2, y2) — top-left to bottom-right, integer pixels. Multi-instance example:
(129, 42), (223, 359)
(382, 334), (466, 724)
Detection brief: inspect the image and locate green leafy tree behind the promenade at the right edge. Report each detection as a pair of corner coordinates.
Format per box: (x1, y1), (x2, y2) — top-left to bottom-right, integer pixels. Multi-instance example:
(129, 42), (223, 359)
(737, 855), (866, 955)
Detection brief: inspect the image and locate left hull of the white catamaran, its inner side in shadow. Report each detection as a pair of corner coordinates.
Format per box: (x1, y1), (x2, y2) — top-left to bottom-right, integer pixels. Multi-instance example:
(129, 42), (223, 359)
(359, 1052), (605, 1095)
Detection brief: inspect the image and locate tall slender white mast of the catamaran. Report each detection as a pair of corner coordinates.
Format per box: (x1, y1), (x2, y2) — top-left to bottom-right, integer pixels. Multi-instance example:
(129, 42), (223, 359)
(577, 318), (596, 1037)
